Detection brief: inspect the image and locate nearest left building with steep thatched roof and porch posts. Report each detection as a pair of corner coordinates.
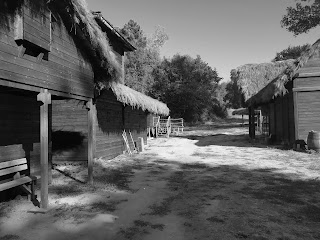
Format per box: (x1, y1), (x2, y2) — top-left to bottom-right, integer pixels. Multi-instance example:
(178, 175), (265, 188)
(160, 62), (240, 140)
(0, 0), (122, 208)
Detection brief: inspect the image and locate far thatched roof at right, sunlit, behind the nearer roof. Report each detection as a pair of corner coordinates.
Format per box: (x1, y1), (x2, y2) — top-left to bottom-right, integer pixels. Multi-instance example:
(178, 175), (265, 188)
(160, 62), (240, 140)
(236, 59), (295, 100)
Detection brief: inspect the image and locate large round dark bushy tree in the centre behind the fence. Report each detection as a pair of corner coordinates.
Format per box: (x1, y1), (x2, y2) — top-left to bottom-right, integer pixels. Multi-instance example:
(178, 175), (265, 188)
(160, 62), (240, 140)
(151, 54), (221, 121)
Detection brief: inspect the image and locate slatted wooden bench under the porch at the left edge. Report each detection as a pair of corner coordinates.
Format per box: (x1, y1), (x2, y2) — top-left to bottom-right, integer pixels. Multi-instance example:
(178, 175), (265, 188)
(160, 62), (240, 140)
(0, 158), (37, 201)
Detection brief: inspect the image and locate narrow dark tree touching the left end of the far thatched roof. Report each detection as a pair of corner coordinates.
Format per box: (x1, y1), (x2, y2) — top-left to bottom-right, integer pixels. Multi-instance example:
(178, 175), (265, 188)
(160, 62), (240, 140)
(223, 69), (245, 108)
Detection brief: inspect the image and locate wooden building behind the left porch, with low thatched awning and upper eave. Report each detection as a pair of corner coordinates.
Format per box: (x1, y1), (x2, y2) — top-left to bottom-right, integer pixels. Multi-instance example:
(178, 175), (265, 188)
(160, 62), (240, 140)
(52, 12), (169, 162)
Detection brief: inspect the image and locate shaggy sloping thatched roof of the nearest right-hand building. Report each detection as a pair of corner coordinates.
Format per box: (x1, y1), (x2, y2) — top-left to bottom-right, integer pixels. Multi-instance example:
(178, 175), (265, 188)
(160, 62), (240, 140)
(247, 39), (320, 105)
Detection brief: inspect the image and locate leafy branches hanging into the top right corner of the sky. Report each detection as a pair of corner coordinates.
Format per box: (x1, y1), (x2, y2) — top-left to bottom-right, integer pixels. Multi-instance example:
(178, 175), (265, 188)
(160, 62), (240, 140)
(281, 0), (320, 35)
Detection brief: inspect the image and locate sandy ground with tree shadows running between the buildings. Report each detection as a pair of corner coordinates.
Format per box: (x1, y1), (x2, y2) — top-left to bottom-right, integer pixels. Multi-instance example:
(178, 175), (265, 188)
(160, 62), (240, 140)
(0, 124), (320, 240)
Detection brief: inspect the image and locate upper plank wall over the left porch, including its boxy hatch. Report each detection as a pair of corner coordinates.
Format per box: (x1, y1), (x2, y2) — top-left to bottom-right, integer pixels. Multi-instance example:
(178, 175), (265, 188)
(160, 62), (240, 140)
(0, 3), (93, 98)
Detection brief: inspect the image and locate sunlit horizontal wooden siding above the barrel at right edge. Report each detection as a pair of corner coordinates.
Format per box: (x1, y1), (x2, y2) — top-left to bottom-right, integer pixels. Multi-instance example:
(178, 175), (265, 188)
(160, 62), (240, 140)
(296, 91), (320, 141)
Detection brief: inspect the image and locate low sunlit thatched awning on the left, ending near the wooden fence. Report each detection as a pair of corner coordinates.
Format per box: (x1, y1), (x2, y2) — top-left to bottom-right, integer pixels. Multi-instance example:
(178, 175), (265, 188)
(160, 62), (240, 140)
(110, 83), (170, 116)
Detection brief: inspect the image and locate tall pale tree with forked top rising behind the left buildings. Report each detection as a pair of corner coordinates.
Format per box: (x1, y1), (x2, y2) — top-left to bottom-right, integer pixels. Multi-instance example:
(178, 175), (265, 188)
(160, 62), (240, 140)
(121, 20), (168, 94)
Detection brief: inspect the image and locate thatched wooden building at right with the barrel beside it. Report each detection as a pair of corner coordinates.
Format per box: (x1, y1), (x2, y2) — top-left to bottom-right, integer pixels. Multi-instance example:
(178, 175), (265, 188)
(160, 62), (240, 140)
(241, 40), (320, 146)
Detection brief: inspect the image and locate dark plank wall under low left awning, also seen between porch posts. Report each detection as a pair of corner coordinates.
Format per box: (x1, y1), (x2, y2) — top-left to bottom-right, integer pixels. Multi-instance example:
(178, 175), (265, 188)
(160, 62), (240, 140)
(47, 90), (147, 161)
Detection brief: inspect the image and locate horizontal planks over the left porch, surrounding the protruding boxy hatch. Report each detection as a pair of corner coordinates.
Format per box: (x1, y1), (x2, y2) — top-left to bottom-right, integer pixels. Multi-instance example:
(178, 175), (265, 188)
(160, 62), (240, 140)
(0, 4), (94, 97)
